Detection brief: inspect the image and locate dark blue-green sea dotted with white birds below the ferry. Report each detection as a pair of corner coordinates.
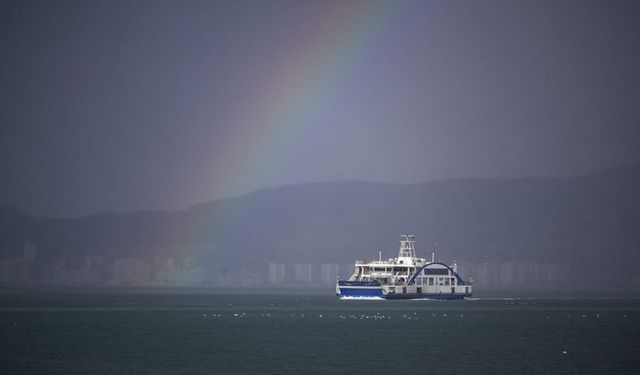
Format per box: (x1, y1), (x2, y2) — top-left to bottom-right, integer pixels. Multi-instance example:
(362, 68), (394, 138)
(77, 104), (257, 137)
(0, 291), (640, 375)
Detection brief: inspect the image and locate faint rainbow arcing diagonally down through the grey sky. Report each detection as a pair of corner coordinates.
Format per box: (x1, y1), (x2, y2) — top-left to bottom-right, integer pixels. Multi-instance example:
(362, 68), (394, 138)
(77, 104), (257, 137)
(192, 1), (406, 247)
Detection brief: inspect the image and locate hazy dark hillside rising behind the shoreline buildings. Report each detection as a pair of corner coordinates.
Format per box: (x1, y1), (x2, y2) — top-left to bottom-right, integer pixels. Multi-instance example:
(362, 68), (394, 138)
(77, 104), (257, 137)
(0, 166), (640, 290)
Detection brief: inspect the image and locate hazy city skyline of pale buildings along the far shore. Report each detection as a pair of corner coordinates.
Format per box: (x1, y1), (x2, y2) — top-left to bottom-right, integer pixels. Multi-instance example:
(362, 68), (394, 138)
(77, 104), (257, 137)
(0, 242), (576, 291)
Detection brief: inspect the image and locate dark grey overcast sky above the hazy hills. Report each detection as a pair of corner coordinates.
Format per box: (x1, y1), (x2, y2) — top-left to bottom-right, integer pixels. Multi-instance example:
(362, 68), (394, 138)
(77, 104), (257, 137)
(0, 0), (640, 216)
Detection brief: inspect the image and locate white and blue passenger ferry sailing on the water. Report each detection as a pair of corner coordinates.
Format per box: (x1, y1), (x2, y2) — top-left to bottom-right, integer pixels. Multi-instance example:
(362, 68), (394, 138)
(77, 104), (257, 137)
(336, 234), (473, 299)
